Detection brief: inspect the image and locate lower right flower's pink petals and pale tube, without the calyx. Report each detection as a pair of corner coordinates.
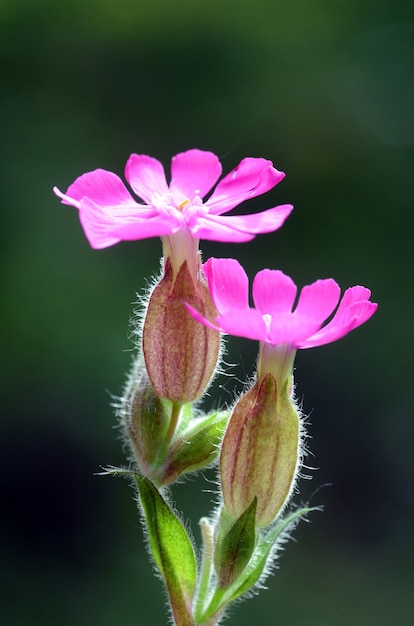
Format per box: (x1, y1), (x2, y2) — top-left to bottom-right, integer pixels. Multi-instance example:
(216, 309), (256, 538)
(187, 258), (378, 379)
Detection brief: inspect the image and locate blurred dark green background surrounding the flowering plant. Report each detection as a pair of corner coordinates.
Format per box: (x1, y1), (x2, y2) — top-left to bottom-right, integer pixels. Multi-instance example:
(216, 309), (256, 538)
(0, 0), (414, 626)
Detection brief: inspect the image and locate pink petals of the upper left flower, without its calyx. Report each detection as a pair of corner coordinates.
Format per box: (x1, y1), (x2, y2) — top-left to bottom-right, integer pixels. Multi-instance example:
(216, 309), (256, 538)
(54, 150), (293, 248)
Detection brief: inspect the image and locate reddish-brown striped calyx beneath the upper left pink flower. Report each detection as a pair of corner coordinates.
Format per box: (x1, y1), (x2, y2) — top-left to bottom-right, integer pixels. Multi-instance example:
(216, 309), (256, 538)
(143, 258), (220, 404)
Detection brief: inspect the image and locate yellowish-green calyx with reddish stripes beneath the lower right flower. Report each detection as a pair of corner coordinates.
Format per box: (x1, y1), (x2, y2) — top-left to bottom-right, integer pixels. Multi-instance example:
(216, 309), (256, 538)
(220, 373), (300, 527)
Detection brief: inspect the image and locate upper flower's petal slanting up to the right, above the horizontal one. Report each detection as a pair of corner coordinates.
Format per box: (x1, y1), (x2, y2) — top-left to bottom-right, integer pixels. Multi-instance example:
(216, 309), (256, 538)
(206, 157), (285, 215)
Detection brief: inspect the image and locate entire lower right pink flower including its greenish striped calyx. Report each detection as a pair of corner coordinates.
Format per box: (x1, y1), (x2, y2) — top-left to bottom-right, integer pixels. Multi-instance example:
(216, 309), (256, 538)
(186, 259), (377, 527)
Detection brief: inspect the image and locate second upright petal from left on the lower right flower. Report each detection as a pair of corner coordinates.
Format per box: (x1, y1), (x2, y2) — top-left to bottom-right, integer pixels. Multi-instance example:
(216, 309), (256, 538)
(253, 270), (297, 315)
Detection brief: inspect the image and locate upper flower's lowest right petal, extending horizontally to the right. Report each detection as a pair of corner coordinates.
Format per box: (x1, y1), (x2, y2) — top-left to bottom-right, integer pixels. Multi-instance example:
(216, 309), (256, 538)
(188, 204), (293, 242)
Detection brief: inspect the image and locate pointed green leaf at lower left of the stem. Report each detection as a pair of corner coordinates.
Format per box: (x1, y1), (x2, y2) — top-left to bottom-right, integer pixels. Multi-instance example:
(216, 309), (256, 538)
(135, 474), (197, 626)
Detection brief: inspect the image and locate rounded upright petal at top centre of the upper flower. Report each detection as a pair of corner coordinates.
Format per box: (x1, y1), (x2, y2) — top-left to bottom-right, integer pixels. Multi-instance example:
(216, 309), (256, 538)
(170, 150), (221, 200)
